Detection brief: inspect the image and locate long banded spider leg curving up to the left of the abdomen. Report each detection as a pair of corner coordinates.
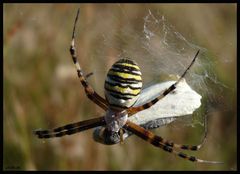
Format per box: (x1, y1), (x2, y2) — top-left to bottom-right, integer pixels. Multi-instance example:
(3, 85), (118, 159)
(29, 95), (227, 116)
(70, 9), (108, 110)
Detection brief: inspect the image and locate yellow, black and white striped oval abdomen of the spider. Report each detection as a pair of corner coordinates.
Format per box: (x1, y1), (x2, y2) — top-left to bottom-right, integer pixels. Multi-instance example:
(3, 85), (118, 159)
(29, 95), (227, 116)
(105, 58), (142, 109)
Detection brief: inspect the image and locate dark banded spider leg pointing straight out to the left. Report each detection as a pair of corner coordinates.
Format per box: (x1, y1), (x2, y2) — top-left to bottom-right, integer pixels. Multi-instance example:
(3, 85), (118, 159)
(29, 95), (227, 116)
(34, 117), (106, 138)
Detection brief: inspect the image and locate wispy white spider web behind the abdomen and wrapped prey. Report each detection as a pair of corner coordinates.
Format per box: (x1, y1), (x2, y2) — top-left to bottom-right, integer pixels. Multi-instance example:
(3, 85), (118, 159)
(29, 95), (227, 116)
(86, 6), (228, 126)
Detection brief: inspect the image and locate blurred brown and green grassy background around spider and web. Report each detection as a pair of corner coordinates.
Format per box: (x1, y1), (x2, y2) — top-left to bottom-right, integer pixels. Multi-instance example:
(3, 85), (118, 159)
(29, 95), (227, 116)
(3, 4), (237, 170)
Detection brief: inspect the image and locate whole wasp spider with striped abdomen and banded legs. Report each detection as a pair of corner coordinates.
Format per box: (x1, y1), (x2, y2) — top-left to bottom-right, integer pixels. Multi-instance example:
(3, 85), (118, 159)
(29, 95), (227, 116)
(34, 9), (221, 164)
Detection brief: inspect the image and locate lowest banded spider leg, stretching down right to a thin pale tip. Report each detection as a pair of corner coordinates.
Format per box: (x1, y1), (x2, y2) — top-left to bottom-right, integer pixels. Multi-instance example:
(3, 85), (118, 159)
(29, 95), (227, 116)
(124, 121), (222, 164)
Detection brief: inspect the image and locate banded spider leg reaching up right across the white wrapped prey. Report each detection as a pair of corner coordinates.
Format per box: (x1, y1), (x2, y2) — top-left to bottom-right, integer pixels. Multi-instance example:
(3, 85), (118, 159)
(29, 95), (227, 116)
(127, 50), (200, 116)
